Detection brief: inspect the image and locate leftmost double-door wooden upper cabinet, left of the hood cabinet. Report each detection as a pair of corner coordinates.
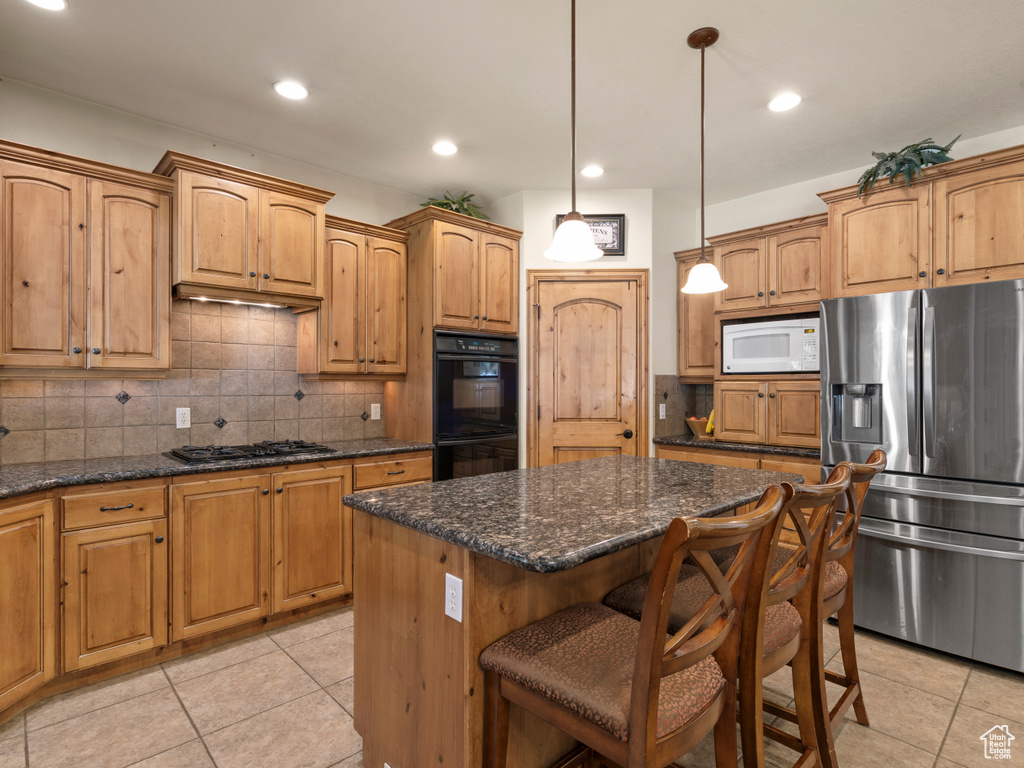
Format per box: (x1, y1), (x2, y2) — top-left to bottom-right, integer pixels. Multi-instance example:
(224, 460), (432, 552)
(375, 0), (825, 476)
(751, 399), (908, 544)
(0, 142), (172, 371)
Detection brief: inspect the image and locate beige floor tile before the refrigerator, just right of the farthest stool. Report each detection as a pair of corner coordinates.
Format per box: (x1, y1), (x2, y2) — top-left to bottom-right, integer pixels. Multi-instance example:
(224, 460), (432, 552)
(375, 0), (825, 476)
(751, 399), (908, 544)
(826, 634), (971, 704)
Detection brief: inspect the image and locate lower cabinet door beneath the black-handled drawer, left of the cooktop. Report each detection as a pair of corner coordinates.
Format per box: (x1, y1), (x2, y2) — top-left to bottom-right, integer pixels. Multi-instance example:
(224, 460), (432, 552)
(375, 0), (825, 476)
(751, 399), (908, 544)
(61, 519), (168, 671)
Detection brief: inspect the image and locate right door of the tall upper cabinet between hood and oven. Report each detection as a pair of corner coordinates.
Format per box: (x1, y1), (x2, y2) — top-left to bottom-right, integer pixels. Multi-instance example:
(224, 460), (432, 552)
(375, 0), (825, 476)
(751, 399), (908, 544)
(366, 238), (409, 374)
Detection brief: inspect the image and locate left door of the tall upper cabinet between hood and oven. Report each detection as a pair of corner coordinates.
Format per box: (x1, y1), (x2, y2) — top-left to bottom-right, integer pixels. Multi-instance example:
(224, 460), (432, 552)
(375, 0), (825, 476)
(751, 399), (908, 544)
(319, 229), (367, 374)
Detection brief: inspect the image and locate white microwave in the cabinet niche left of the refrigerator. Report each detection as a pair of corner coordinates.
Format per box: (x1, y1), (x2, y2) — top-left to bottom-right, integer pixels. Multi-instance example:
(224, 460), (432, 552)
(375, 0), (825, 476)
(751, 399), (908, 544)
(722, 317), (821, 374)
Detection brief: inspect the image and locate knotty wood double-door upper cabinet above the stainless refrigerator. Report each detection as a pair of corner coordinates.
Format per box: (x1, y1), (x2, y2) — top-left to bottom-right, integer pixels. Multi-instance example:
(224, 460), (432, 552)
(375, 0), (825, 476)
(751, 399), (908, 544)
(820, 146), (1024, 296)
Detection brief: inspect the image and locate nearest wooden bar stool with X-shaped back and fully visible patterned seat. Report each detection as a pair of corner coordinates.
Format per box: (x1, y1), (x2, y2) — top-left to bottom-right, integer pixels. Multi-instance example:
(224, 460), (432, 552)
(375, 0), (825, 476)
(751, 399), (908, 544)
(480, 485), (793, 768)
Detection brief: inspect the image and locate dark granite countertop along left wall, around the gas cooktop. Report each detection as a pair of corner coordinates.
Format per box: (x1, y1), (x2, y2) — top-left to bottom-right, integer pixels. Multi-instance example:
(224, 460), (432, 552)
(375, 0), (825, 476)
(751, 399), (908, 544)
(0, 437), (434, 499)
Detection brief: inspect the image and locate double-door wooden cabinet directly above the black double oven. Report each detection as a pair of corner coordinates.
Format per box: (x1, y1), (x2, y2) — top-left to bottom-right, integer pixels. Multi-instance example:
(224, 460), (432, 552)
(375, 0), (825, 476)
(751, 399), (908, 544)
(388, 208), (522, 335)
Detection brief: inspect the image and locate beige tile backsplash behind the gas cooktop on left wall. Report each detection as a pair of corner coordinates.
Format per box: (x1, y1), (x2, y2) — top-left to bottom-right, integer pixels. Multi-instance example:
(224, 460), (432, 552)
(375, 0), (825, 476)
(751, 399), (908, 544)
(0, 301), (384, 464)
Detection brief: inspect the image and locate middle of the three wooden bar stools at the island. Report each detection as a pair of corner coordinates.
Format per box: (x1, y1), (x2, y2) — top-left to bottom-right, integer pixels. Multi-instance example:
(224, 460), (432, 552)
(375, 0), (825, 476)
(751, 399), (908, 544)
(604, 468), (851, 768)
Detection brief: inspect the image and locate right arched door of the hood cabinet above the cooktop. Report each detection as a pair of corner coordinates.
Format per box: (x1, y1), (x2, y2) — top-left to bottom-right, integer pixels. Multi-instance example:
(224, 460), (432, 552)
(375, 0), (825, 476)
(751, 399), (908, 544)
(259, 190), (324, 298)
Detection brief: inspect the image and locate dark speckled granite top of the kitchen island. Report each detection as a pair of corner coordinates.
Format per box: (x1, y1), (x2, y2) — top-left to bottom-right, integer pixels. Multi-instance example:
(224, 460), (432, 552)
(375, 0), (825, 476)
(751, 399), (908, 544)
(345, 456), (800, 572)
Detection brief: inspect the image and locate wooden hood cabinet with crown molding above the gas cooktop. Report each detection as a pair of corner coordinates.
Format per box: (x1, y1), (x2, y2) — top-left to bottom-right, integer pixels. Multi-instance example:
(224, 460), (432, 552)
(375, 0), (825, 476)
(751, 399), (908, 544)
(155, 152), (333, 306)
